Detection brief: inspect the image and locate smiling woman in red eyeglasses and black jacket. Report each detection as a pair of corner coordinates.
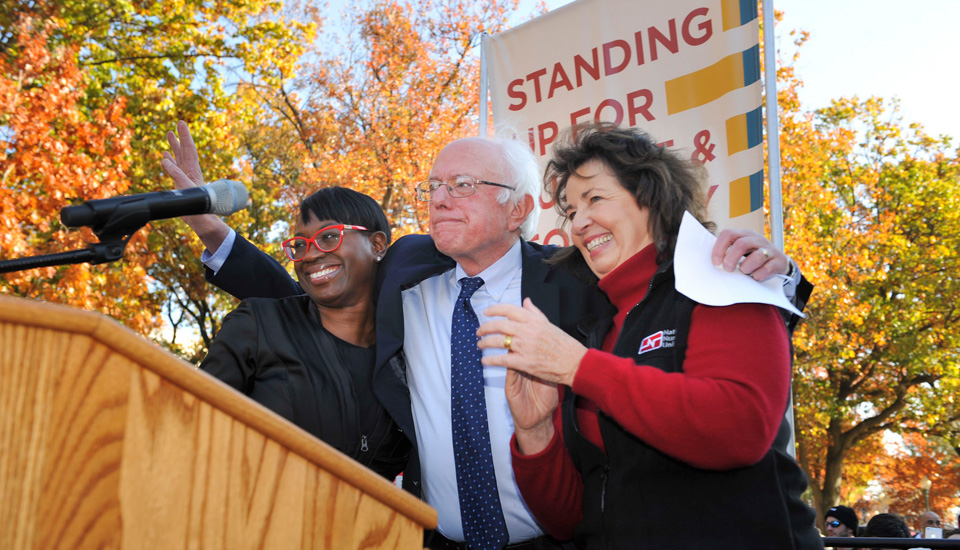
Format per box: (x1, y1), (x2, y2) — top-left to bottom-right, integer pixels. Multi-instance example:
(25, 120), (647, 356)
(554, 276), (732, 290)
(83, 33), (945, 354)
(200, 187), (409, 479)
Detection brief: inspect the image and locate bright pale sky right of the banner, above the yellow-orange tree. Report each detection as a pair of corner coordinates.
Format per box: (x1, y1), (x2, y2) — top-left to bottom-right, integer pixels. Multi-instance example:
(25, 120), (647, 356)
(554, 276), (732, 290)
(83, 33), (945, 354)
(532, 0), (960, 137)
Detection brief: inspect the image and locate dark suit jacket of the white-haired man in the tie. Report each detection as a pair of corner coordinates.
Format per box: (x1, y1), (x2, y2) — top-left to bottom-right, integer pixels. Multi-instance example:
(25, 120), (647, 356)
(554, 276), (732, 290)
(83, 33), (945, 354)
(207, 235), (611, 496)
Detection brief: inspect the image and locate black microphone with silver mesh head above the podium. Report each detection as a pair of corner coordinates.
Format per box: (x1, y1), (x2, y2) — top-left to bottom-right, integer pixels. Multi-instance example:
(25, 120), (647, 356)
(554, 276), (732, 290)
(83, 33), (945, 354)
(60, 180), (247, 228)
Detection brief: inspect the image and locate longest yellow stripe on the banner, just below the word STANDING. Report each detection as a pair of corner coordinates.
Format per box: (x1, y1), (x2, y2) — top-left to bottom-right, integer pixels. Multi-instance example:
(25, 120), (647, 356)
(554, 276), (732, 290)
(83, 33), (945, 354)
(664, 52), (743, 115)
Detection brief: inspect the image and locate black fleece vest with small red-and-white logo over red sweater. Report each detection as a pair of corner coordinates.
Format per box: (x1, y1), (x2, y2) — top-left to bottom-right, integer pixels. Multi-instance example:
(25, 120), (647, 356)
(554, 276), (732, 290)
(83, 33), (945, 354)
(563, 262), (823, 550)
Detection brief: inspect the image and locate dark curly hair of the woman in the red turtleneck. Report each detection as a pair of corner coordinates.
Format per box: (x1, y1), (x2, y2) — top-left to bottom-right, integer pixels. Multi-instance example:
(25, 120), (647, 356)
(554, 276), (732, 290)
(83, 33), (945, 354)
(543, 122), (714, 263)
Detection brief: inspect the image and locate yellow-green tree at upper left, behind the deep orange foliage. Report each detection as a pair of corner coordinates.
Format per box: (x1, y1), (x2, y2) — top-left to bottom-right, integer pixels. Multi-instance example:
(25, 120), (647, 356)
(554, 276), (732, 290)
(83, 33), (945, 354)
(0, 0), (315, 356)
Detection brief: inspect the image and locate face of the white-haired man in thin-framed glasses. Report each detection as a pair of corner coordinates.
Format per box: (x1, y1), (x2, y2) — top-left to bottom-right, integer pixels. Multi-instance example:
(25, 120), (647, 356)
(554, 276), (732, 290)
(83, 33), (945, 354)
(430, 138), (533, 276)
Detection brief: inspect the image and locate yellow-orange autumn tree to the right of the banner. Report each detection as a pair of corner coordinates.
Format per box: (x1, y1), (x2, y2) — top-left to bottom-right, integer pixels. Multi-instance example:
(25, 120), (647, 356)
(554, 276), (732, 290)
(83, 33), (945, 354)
(779, 25), (960, 517)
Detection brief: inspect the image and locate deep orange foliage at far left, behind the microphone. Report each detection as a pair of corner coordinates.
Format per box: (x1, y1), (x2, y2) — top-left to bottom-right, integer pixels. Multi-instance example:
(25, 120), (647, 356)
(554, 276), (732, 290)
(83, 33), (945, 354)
(0, 19), (157, 333)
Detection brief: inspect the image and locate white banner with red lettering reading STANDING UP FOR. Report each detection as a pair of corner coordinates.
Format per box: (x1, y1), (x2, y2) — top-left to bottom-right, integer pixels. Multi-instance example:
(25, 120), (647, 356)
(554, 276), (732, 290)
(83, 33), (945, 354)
(485, 0), (763, 245)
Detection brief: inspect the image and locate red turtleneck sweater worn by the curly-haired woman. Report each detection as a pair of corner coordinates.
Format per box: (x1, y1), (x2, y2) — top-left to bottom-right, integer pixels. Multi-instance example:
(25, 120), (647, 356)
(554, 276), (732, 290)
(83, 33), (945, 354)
(512, 246), (790, 540)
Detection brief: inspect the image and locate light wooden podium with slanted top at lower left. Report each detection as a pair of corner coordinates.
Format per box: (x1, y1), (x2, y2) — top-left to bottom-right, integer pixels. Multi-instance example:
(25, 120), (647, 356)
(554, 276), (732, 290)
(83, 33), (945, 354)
(0, 297), (437, 550)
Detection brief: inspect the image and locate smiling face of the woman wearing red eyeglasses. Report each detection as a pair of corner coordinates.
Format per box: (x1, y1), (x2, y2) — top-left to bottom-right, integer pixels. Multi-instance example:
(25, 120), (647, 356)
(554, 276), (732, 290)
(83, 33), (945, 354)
(294, 216), (386, 308)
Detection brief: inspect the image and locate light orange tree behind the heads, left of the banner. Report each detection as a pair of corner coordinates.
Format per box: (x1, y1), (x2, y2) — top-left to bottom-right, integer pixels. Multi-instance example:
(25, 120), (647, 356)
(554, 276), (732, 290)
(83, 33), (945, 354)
(244, 0), (517, 234)
